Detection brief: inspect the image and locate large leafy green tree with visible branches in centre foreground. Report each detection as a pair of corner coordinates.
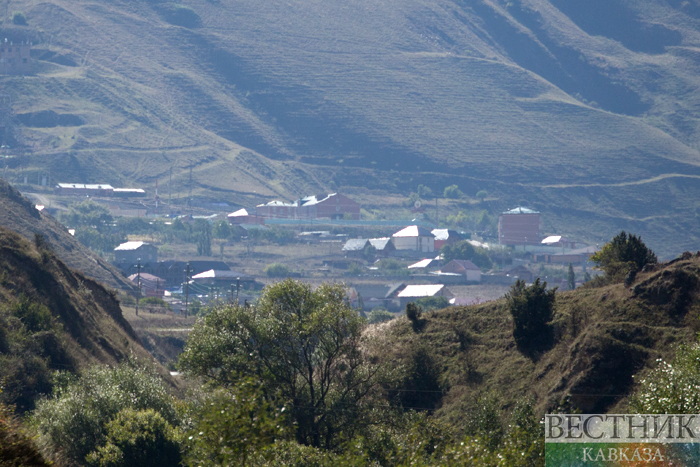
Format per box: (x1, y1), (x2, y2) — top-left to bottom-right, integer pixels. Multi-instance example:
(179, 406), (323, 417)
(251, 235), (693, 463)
(180, 279), (380, 448)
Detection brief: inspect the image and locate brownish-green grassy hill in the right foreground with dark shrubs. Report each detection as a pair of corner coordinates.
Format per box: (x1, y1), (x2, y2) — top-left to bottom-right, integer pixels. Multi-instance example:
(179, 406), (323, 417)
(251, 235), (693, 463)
(372, 255), (700, 426)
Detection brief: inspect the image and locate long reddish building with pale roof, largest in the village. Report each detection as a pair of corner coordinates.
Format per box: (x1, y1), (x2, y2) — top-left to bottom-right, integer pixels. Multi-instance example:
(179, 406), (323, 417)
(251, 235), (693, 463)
(255, 193), (360, 220)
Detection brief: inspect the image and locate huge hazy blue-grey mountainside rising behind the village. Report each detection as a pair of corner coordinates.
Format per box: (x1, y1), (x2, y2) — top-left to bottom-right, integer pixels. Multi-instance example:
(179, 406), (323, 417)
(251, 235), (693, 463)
(0, 0), (700, 256)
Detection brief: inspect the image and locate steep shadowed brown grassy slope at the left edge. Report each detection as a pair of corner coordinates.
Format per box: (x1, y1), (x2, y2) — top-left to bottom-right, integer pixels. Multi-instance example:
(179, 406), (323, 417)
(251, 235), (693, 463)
(0, 227), (159, 411)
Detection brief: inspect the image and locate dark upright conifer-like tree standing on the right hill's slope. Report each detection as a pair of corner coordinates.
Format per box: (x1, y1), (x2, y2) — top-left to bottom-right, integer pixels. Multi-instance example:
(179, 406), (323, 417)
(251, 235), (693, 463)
(506, 277), (557, 351)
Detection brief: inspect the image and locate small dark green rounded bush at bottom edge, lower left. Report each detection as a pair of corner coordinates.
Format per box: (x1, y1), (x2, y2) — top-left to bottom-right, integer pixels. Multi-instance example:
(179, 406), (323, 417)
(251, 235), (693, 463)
(87, 409), (182, 467)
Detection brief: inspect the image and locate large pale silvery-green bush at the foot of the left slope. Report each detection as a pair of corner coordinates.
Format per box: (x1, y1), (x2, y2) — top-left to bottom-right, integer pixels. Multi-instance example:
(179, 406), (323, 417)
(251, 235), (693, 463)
(31, 360), (179, 464)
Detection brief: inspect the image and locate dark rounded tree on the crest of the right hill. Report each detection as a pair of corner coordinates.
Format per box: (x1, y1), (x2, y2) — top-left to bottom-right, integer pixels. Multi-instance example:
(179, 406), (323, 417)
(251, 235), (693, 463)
(591, 230), (657, 281)
